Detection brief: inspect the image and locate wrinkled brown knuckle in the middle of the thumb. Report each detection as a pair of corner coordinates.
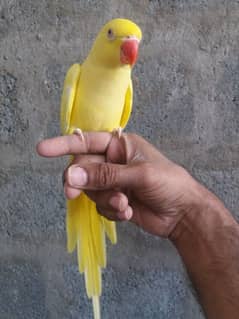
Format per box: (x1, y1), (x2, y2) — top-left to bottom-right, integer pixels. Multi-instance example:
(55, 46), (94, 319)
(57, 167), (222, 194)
(95, 163), (118, 188)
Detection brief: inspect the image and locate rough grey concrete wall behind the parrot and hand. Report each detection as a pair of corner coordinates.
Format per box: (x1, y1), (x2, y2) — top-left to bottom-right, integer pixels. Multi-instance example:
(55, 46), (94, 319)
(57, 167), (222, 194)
(0, 0), (239, 319)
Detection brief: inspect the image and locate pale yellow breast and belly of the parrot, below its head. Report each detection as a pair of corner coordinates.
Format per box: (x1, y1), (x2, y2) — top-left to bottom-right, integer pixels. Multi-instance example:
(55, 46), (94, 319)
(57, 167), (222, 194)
(71, 64), (130, 131)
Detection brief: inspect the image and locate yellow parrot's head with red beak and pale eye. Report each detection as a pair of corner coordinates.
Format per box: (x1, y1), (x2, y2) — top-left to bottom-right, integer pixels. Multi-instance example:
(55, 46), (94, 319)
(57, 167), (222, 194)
(90, 19), (142, 67)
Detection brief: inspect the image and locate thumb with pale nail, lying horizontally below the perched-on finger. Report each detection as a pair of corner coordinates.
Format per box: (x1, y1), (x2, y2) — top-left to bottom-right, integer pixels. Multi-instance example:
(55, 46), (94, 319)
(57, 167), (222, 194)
(65, 163), (141, 190)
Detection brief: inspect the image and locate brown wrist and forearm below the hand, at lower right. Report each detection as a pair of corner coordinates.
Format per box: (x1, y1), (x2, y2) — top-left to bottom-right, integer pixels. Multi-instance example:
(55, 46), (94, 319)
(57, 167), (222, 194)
(170, 182), (239, 319)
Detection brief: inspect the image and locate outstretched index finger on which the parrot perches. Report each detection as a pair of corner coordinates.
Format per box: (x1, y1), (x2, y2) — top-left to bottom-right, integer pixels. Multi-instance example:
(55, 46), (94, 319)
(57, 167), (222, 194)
(36, 132), (112, 157)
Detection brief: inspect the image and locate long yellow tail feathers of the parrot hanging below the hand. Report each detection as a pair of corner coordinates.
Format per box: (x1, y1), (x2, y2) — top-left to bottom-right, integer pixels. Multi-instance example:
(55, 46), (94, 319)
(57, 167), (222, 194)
(66, 193), (117, 319)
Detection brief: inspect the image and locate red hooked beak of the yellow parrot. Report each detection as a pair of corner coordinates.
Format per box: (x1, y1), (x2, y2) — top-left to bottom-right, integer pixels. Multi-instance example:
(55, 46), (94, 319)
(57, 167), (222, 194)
(120, 36), (139, 65)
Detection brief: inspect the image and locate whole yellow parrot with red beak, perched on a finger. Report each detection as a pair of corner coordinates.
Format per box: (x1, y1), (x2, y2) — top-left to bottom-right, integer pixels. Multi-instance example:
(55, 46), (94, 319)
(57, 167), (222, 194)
(60, 19), (142, 319)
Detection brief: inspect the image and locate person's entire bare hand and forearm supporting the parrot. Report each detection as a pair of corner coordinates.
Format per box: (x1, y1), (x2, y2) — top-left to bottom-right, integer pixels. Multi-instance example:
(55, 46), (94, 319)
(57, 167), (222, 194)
(37, 132), (239, 319)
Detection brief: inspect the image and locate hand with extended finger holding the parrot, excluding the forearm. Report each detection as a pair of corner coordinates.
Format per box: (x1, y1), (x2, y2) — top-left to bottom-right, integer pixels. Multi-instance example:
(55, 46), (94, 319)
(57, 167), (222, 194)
(37, 132), (203, 237)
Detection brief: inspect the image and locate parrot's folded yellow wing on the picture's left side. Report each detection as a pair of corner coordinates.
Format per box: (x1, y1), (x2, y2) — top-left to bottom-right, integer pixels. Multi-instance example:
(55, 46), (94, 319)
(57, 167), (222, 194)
(61, 63), (81, 134)
